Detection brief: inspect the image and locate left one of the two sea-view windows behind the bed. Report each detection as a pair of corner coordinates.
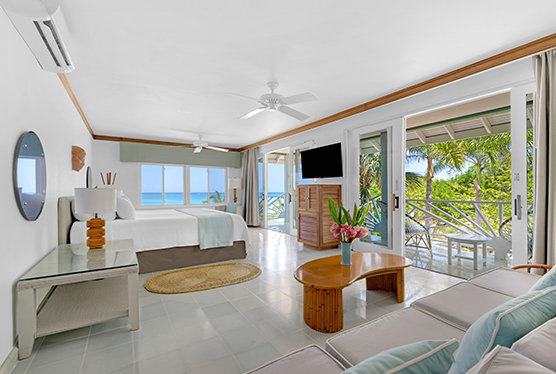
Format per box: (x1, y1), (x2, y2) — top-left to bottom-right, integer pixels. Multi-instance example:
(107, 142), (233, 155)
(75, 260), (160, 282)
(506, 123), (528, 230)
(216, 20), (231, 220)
(141, 165), (184, 205)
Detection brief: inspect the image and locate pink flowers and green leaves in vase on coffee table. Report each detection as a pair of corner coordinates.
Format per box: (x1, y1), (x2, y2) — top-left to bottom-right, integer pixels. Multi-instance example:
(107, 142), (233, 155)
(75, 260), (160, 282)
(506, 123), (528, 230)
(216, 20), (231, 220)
(328, 197), (370, 243)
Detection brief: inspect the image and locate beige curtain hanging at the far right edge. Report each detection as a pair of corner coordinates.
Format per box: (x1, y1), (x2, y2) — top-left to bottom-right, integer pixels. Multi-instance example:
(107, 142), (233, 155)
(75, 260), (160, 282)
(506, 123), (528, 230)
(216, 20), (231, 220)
(533, 50), (556, 265)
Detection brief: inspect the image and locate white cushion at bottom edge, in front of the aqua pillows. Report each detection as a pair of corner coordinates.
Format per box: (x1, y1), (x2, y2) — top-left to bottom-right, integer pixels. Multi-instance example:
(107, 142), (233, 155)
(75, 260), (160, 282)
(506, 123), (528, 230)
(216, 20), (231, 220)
(465, 346), (554, 374)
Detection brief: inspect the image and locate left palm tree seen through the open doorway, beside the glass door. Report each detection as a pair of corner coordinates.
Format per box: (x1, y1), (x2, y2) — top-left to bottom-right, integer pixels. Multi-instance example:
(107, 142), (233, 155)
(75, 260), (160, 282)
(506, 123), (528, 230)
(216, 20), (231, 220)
(406, 141), (465, 224)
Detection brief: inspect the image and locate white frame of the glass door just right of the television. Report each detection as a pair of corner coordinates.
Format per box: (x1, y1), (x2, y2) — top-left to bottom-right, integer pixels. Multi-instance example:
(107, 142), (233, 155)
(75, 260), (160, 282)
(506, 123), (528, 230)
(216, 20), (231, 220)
(344, 117), (405, 256)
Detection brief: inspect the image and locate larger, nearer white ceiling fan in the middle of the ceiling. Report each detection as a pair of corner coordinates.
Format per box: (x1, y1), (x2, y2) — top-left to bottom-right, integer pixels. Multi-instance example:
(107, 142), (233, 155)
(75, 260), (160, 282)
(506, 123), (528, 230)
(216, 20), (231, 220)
(232, 82), (317, 121)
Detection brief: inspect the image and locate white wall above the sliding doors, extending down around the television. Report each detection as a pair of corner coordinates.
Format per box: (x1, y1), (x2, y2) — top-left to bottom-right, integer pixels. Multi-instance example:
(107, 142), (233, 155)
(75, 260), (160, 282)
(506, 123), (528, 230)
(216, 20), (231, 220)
(259, 58), (534, 206)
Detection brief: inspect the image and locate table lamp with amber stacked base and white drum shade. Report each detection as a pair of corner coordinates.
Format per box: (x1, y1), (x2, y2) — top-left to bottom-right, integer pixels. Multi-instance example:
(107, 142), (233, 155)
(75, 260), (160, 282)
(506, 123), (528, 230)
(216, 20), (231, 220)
(75, 188), (116, 249)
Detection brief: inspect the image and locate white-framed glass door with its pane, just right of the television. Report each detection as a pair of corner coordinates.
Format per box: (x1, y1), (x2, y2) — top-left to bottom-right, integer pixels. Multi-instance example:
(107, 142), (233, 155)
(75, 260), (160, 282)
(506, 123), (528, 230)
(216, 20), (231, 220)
(350, 118), (405, 255)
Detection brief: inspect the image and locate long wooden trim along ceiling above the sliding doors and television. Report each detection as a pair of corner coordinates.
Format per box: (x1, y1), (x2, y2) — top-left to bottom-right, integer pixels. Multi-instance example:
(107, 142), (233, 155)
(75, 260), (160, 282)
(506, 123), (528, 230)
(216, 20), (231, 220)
(239, 34), (556, 151)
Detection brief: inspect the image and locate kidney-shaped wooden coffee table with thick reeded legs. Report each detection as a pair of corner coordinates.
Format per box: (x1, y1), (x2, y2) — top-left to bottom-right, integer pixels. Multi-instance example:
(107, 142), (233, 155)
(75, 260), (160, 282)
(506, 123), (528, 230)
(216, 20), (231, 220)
(294, 253), (413, 333)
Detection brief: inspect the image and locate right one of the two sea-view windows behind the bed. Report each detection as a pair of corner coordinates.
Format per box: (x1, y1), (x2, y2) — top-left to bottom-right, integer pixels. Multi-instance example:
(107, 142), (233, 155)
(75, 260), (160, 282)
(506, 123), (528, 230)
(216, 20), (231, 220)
(189, 167), (226, 204)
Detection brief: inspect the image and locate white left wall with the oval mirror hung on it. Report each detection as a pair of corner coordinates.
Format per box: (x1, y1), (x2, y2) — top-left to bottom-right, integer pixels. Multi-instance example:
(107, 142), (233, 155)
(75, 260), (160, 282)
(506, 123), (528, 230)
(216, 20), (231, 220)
(0, 8), (92, 363)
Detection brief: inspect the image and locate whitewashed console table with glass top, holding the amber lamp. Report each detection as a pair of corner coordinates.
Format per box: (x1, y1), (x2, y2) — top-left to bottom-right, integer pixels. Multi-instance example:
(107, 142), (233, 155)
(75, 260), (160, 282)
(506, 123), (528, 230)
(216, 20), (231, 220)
(16, 239), (139, 360)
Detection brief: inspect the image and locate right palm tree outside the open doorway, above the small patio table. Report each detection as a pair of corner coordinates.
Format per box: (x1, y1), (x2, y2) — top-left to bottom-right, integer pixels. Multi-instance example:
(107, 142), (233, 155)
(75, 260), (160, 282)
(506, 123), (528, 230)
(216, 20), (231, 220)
(460, 133), (511, 225)
